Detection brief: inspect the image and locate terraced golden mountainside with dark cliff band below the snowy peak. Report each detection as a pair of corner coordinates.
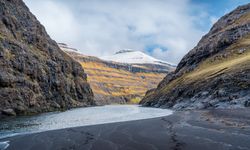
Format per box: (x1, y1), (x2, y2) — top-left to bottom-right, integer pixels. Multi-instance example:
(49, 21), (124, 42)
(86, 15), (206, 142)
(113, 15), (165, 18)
(59, 43), (174, 105)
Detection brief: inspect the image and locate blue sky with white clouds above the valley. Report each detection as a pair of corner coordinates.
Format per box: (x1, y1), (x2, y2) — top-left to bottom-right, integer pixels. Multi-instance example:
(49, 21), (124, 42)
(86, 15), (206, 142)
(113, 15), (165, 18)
(24, 0), (250, 64)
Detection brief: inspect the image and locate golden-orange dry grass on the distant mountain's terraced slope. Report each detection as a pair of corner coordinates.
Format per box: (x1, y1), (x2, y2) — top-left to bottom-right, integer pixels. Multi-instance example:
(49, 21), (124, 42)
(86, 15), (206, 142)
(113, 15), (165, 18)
(80, 62), (165, 100)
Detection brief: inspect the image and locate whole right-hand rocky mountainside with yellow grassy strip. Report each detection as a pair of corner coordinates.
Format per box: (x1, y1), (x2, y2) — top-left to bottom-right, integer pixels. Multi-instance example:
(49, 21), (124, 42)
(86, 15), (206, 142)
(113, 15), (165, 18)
(140, 4), (250, 110)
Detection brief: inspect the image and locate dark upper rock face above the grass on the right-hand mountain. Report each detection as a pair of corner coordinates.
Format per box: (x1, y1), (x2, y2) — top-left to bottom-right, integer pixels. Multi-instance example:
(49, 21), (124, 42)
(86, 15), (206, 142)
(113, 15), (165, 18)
(176, 4), (250, 76)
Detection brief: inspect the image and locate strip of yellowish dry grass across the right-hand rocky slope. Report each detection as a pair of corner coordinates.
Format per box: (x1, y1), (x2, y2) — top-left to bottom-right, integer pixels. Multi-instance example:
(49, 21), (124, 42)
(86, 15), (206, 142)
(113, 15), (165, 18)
(159, 36), (250, 92)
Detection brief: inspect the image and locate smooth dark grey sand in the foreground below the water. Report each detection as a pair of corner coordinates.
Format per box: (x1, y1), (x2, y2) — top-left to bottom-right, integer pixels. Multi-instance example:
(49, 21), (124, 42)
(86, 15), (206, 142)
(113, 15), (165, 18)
(0, 109), (250, 150)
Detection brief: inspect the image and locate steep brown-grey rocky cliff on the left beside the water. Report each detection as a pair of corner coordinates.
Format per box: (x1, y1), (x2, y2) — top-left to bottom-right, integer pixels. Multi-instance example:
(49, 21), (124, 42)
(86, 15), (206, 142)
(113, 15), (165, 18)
(0, 0), (93, 115)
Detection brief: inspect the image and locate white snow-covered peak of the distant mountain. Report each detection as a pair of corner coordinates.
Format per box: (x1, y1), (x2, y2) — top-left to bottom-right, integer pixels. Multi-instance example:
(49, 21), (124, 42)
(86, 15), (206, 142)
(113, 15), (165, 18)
(101, 50), (175, 67)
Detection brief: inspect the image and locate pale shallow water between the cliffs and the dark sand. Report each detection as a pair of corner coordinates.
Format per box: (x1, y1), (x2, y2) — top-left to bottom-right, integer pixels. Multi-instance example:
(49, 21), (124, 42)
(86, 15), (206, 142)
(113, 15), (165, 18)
(0, 105), (172, 138)
